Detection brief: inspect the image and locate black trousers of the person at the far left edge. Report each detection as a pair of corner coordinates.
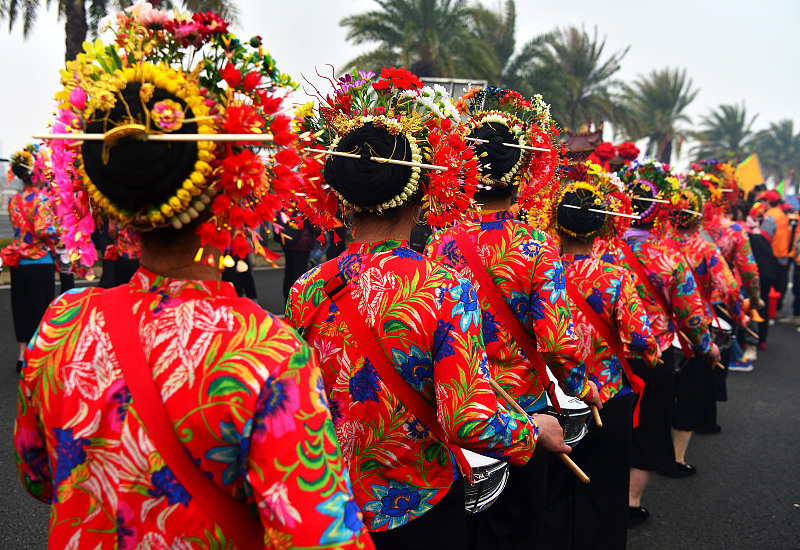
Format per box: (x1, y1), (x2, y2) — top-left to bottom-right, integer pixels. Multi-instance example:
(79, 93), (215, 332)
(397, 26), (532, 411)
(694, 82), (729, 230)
(10, 264), (56, 344)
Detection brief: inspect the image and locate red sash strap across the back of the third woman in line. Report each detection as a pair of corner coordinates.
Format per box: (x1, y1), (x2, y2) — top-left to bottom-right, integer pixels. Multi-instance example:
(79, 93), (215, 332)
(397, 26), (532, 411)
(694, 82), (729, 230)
(455, 231), (561, 414)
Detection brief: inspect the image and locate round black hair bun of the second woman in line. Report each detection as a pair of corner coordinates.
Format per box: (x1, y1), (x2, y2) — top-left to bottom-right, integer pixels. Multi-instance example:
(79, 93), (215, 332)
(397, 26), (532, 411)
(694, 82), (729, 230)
(324, 122), (411, 208)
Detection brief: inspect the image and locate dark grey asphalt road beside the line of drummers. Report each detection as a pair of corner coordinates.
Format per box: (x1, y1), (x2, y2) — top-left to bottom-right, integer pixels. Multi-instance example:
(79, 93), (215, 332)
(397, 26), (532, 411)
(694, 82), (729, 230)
(0, 269), (800, 550)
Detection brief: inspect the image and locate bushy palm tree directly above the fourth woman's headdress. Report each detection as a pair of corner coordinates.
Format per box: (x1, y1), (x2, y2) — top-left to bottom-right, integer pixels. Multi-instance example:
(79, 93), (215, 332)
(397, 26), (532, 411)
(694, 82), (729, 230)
(505, 26), (628, 133)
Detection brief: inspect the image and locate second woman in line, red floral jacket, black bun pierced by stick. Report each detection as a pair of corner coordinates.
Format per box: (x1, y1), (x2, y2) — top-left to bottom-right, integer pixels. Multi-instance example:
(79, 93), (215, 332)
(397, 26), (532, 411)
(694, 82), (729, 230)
(286, 67), (536, 548)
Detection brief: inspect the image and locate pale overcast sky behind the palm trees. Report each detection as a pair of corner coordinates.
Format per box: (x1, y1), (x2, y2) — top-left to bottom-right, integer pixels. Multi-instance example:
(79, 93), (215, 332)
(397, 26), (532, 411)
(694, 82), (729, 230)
(0, 0), (800, 171)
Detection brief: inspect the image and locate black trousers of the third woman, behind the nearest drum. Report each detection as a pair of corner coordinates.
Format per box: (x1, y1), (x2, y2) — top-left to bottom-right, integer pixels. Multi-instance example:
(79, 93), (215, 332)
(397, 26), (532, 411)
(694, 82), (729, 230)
(468, 450), (550, 550)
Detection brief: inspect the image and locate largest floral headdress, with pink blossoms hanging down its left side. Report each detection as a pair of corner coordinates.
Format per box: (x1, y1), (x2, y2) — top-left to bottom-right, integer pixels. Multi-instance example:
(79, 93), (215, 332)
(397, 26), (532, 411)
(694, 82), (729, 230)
(51, 0), (300, 270)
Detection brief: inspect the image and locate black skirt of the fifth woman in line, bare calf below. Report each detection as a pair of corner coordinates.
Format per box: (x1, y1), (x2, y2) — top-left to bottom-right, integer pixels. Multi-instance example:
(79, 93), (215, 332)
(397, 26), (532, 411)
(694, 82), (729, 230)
(628, 348), (675, 471)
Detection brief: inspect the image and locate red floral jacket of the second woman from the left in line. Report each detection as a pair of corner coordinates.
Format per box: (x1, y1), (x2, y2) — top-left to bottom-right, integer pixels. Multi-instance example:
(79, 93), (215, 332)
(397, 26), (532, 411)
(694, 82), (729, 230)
(286, 240), (538, 531)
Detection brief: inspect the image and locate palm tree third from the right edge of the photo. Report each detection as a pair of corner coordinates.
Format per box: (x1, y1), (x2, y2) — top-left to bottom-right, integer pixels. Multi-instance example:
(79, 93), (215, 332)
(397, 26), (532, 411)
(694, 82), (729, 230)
(620, 68), (700, 164)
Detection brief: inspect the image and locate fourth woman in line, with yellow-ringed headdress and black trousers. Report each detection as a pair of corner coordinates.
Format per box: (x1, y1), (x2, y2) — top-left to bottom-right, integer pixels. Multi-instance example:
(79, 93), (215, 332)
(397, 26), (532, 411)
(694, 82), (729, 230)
(545, 166), (660, 550)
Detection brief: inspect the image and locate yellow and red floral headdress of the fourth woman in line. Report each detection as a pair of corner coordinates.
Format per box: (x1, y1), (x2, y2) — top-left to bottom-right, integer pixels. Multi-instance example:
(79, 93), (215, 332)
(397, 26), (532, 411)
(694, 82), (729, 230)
(547, 160), (633, 244)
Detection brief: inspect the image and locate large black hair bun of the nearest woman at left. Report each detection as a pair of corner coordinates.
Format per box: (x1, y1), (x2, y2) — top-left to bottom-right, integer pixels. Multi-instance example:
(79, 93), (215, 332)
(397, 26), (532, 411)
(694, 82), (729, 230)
(82, 83), (197, 216)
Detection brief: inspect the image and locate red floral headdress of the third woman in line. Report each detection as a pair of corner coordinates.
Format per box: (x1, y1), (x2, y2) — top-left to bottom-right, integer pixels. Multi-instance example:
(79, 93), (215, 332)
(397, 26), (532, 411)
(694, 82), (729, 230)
(456, 86), (564, 210)
